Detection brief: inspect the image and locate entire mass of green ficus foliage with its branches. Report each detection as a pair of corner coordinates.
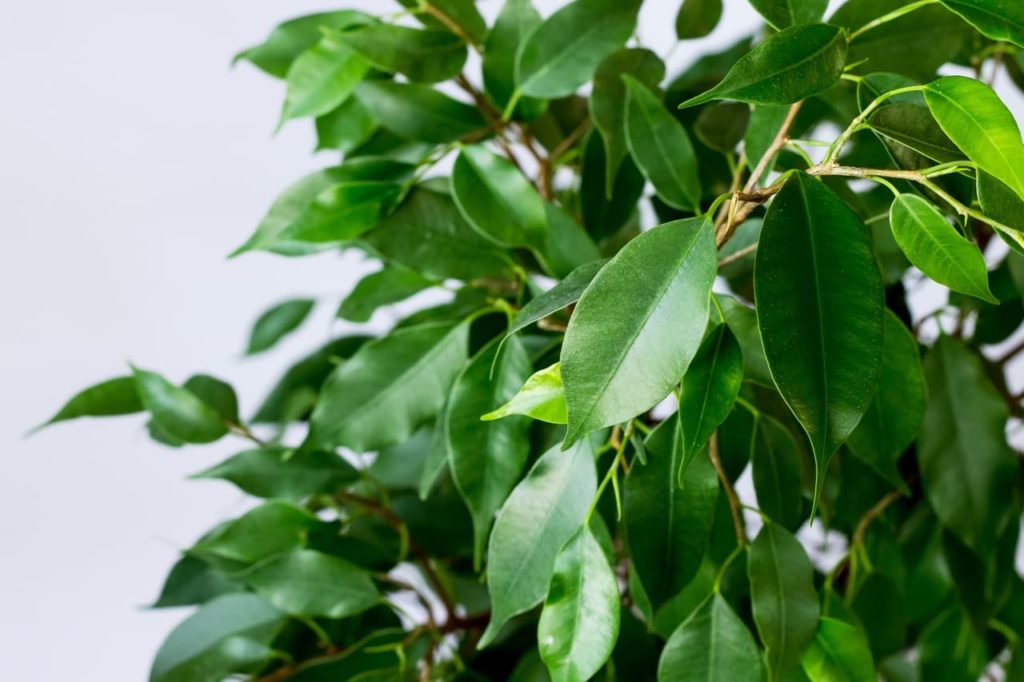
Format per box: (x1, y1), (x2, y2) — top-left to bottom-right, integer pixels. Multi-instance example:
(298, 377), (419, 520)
(44, 0), (1024, 682)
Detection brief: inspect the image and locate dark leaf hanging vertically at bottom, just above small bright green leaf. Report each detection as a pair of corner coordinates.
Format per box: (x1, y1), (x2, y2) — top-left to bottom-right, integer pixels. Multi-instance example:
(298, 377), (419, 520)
(746, 523), (819, 680)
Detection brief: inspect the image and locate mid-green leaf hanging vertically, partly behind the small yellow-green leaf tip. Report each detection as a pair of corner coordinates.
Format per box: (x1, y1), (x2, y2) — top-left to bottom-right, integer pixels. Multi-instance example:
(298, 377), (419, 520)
(445, 338), (531, 566)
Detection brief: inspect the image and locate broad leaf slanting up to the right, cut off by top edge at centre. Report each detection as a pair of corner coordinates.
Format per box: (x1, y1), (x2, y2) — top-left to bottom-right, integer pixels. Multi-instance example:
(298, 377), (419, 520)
(515, 0), (640, 99)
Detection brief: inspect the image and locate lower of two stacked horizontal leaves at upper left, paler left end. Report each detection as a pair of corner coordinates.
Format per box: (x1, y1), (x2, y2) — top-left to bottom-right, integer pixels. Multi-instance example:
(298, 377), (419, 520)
(355, 81), (487, 144)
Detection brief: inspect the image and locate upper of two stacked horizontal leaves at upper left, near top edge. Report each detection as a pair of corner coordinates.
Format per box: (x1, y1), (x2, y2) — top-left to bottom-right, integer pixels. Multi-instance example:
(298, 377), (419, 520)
(339, 24), (466, 83)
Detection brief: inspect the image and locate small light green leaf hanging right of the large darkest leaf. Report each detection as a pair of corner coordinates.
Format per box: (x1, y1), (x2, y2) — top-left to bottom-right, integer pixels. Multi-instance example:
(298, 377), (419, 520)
(889, 195), (998, 303)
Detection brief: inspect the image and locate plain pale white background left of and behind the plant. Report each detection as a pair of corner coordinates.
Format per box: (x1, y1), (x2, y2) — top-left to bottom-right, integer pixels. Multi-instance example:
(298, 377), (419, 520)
(0, 0), (1007, 682)
